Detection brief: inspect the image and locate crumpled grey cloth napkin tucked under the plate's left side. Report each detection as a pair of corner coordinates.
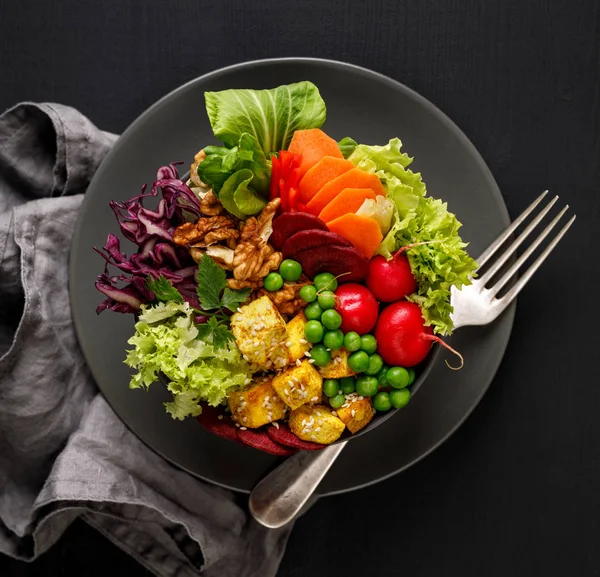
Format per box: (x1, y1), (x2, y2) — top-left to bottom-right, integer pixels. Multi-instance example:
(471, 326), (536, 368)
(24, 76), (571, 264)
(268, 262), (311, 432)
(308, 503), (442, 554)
(0, 103), (291, 577)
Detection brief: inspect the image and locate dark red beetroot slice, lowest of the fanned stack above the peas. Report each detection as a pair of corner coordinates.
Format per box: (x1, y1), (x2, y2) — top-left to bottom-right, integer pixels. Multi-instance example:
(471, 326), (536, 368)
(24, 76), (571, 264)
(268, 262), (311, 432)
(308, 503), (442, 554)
(294, 246), (369, 284)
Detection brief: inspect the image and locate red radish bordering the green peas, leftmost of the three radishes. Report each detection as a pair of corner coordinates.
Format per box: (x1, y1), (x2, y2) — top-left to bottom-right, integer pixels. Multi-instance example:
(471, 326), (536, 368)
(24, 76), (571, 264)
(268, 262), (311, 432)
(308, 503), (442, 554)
(335, 283), (378, 335)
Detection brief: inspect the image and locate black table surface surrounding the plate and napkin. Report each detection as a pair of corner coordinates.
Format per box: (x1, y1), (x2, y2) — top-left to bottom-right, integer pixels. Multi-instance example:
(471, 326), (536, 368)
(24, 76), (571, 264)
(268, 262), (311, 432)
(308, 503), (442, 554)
(0, 0), (600, 577)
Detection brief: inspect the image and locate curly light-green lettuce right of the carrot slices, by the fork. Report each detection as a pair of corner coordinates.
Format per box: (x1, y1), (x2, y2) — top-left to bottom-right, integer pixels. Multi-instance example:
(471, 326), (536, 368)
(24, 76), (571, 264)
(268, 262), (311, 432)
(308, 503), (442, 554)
(349, 138), (477, 335)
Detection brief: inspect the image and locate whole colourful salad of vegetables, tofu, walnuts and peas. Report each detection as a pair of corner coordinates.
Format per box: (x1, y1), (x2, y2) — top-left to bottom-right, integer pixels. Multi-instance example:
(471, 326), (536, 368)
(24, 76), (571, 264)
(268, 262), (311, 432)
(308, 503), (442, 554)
(95, 81), (477, 456)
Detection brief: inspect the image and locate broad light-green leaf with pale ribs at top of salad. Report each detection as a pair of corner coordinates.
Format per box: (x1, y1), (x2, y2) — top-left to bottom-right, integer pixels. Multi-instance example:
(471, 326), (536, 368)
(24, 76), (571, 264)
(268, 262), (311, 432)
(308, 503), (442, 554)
(204, 81), (326, 156)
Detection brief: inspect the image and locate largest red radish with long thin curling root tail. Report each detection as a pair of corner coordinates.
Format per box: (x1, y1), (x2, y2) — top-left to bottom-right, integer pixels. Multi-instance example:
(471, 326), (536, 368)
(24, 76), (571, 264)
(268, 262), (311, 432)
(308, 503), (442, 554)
(375, 301), (463, 369)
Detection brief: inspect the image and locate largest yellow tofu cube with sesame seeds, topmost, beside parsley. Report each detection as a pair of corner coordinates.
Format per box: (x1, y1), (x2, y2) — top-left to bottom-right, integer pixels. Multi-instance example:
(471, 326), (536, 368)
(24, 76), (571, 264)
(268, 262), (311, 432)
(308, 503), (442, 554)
(231, 296), (287, 369)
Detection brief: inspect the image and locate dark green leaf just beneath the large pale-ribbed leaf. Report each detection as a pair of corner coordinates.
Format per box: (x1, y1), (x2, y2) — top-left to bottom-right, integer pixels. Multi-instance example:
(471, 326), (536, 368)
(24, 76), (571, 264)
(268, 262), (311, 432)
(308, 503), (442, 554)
(198, 132), (271, 196)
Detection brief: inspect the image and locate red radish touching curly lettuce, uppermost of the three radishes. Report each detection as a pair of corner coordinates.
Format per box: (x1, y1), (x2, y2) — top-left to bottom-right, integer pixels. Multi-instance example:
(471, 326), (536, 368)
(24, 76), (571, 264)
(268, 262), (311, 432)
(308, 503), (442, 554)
(366, 251), (417, 303)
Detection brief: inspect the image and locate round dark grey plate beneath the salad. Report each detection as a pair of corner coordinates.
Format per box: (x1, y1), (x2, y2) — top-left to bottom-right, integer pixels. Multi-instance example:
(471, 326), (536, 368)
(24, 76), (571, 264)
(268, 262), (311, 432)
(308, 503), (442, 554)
(70, 58), (514, 495)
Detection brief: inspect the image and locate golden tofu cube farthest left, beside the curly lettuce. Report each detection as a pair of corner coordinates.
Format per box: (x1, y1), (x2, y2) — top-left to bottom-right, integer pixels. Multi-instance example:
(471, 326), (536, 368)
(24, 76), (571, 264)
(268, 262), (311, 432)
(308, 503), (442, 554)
(228, 378), (287, 429)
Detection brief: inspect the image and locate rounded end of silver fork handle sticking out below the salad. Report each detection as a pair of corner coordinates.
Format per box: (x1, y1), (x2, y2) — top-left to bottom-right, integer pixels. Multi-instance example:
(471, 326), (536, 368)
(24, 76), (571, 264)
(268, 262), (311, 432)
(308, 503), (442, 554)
(249, 441), (347, 529)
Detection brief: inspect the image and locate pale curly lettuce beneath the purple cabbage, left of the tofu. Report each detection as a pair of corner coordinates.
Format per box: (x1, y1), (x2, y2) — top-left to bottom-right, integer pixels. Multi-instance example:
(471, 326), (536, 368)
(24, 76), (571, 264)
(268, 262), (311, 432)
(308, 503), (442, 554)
(125, 301), (252, 419)
